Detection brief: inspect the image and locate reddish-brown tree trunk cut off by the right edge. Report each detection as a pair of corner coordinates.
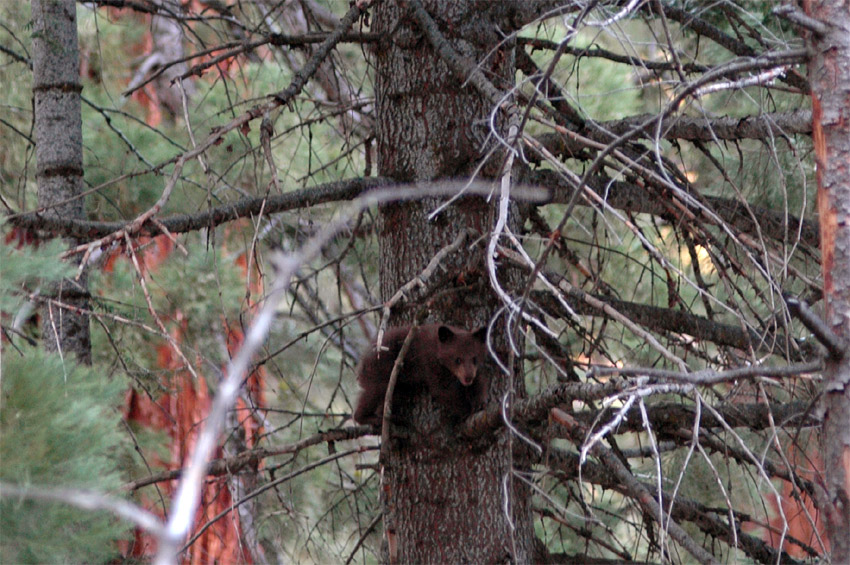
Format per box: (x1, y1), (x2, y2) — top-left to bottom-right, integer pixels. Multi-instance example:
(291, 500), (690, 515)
(806, 0), (850, 563)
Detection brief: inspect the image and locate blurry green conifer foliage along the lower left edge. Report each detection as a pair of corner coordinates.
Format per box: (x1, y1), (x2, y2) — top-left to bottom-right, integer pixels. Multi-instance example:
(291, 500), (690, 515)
(0, 238), (128, 563)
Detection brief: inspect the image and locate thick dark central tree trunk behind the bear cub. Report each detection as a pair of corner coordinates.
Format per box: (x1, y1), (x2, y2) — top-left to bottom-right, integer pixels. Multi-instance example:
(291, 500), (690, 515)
(374, 0), (533, 563)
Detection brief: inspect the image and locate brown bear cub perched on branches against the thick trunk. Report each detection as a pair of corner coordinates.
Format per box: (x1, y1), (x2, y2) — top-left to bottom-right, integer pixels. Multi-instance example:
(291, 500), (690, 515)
(354, 324), (487, 425)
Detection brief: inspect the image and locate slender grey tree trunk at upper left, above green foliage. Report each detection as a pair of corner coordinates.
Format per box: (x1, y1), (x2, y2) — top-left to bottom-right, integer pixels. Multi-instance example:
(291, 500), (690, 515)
(32, 0), (91, 363)
